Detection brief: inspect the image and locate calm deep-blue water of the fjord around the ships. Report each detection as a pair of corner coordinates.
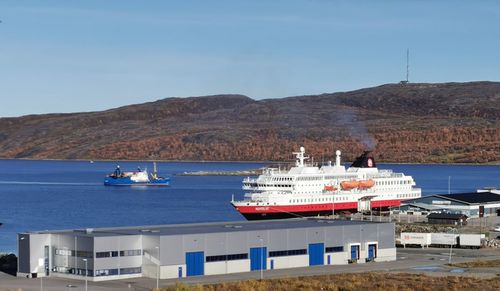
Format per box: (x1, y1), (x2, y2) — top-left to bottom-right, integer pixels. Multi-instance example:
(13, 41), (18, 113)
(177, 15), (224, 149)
(0, 160), (500, 252)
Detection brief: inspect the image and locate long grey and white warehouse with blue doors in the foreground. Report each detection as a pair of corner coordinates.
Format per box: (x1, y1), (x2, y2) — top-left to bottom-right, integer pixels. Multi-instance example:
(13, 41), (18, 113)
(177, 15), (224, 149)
(18, 219), (396, 281)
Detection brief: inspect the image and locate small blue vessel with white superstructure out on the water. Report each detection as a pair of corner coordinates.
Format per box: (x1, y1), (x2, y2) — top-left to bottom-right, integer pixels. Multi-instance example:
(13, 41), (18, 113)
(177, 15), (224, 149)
(104, 162), (170, 186)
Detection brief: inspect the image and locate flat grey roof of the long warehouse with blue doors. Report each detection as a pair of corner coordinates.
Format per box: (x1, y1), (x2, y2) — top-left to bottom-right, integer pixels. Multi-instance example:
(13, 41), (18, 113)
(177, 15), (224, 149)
(27, 218), (387, 237)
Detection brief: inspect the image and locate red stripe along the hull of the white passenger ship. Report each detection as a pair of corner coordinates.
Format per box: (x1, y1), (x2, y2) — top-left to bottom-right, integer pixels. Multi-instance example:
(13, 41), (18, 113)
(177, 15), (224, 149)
(236, 200), (401, 213)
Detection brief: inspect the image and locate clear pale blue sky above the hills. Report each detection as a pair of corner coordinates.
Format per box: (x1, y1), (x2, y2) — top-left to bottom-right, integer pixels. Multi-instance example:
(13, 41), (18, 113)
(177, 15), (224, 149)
(0, 0), (500, 117)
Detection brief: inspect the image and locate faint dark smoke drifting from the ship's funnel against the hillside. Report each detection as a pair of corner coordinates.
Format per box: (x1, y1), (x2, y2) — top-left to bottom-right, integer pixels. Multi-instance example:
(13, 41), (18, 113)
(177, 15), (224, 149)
(337, 108), (377, 151)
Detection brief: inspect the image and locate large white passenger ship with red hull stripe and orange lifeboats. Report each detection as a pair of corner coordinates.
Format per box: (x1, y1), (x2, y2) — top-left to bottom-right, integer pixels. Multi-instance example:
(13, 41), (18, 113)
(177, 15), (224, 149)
(231, 147), (422, 220)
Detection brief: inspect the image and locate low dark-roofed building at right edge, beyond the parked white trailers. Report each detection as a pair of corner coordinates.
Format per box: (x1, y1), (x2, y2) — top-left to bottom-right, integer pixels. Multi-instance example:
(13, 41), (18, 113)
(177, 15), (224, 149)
(391, 190), (500, 218)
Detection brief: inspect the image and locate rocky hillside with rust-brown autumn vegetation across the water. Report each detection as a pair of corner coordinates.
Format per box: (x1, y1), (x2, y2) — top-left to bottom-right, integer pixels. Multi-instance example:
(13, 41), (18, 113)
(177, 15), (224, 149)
(0, 82), (500, 163)
